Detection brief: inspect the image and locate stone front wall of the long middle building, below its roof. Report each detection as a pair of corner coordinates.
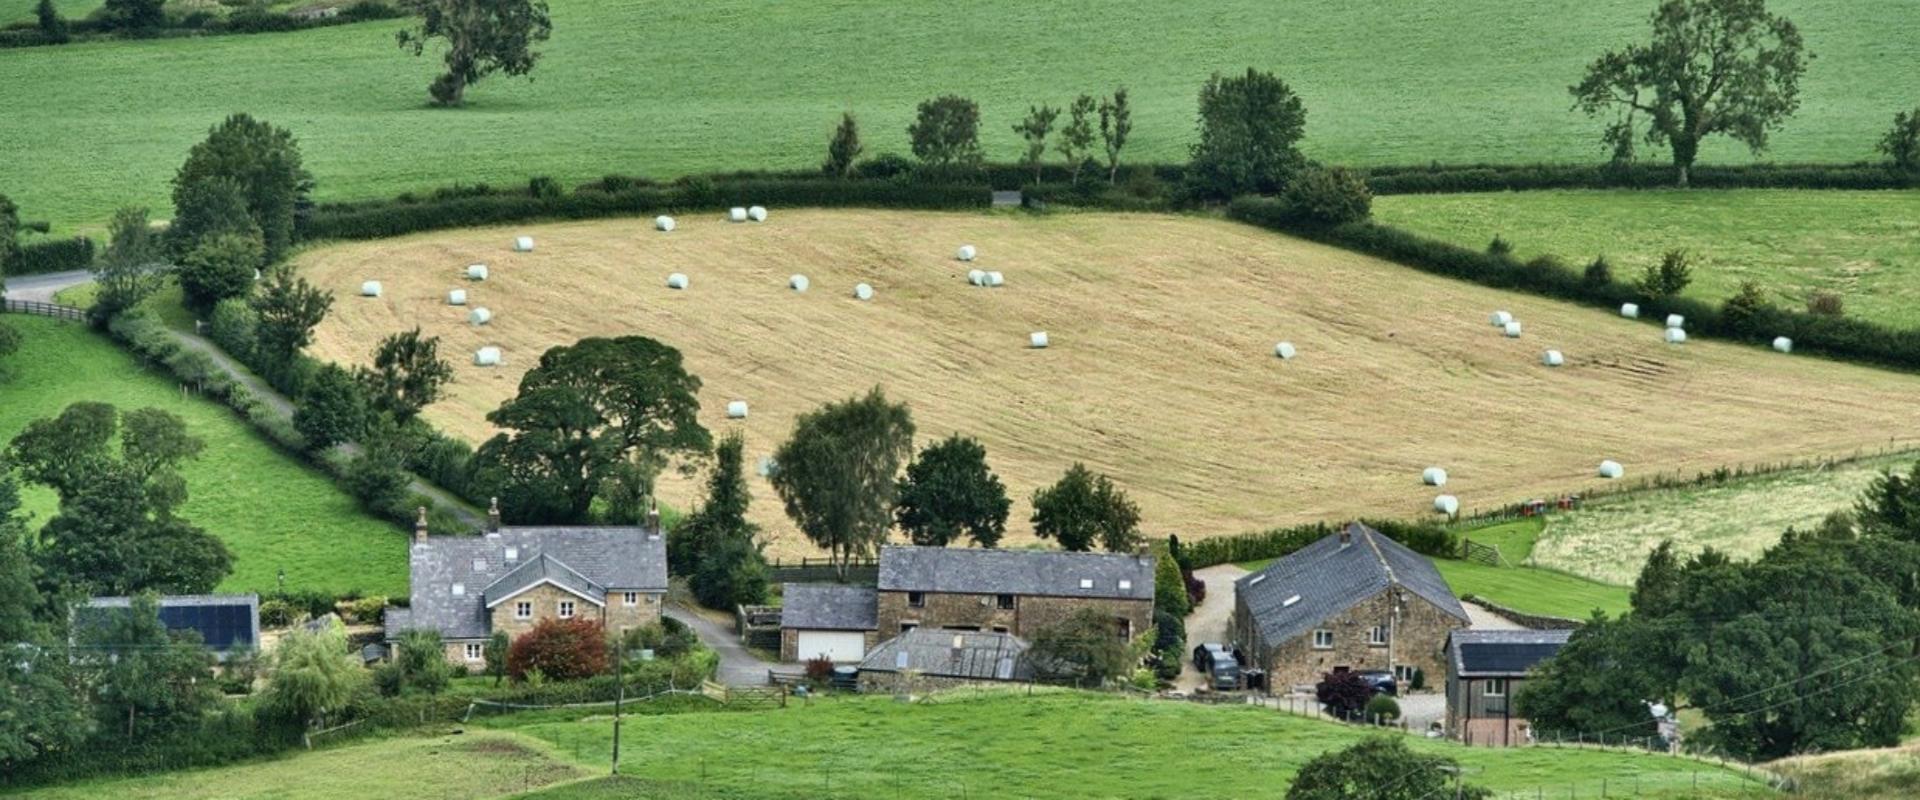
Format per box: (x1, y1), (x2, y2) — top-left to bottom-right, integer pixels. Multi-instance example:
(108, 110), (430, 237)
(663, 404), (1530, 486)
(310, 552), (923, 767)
(877, 591), (1154, 639)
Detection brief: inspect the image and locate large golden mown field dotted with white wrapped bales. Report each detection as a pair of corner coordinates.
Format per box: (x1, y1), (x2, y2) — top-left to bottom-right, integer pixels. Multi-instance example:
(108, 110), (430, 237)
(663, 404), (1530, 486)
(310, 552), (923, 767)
(296, 209), (1920, 554)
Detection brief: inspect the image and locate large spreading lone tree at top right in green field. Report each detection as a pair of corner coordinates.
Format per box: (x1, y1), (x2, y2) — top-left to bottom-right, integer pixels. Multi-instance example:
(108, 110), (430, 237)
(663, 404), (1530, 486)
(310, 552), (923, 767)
(1569, 0), (1811, 186)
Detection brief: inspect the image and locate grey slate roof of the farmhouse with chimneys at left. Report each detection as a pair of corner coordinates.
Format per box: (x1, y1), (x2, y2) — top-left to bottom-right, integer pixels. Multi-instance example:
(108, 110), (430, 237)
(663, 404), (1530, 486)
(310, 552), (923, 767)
(386, 528), (666, 639)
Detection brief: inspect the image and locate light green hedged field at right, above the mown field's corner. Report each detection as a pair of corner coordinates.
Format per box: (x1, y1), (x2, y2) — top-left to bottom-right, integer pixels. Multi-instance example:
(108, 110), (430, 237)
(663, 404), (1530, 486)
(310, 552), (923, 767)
(1373, 189), (1920, 328)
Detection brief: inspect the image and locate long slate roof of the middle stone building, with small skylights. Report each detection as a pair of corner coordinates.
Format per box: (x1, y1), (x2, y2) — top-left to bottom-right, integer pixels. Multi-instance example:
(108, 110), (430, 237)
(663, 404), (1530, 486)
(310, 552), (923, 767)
(879, 547), (1154, 600)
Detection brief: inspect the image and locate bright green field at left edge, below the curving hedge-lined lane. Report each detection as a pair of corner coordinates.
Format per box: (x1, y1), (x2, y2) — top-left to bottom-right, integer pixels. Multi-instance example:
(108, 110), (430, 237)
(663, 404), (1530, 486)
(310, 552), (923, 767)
(0, 315), (407, 595)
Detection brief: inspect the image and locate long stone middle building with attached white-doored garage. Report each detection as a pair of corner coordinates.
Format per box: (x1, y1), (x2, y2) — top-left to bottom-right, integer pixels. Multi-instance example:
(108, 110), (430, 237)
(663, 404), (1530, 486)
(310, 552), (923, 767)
(780, 547), (1154, 664)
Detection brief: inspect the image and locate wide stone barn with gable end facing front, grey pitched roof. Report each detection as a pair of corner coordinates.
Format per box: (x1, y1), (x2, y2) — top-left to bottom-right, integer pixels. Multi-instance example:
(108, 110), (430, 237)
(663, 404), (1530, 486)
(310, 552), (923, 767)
(1231, 524), (1469, 691)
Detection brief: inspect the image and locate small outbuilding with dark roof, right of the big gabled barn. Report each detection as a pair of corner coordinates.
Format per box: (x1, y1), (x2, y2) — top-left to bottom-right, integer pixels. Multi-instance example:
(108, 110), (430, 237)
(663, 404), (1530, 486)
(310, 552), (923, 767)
(1446, 629), (1572, 746)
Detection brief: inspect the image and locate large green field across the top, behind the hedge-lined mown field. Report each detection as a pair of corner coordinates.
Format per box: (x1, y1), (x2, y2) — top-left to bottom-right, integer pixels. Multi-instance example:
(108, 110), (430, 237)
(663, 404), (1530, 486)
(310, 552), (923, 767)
(0, 0), (1920, 228)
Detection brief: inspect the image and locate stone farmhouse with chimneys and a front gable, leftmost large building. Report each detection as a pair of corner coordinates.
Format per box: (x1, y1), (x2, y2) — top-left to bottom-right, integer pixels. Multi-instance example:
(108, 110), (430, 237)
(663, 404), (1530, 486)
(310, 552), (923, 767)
(386, 505), (666, 666)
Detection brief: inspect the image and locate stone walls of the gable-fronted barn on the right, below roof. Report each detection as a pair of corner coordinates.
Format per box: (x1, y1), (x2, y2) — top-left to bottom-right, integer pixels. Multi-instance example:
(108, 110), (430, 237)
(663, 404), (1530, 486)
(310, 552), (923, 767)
(1233, 589), (1467, 693)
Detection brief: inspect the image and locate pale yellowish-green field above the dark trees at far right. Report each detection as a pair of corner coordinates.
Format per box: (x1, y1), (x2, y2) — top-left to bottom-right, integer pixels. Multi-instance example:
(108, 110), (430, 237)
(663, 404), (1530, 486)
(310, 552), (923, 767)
(1532, 455), (1916, 585)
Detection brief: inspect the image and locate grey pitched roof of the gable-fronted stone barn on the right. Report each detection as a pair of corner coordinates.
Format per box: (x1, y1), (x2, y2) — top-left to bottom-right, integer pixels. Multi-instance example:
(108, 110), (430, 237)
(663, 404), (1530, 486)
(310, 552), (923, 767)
(1233, 522), (1469, 645)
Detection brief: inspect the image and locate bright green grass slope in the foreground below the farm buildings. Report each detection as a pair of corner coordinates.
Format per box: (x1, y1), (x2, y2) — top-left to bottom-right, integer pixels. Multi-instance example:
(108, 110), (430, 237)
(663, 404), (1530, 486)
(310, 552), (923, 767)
(503, 691), (1743, 800)
